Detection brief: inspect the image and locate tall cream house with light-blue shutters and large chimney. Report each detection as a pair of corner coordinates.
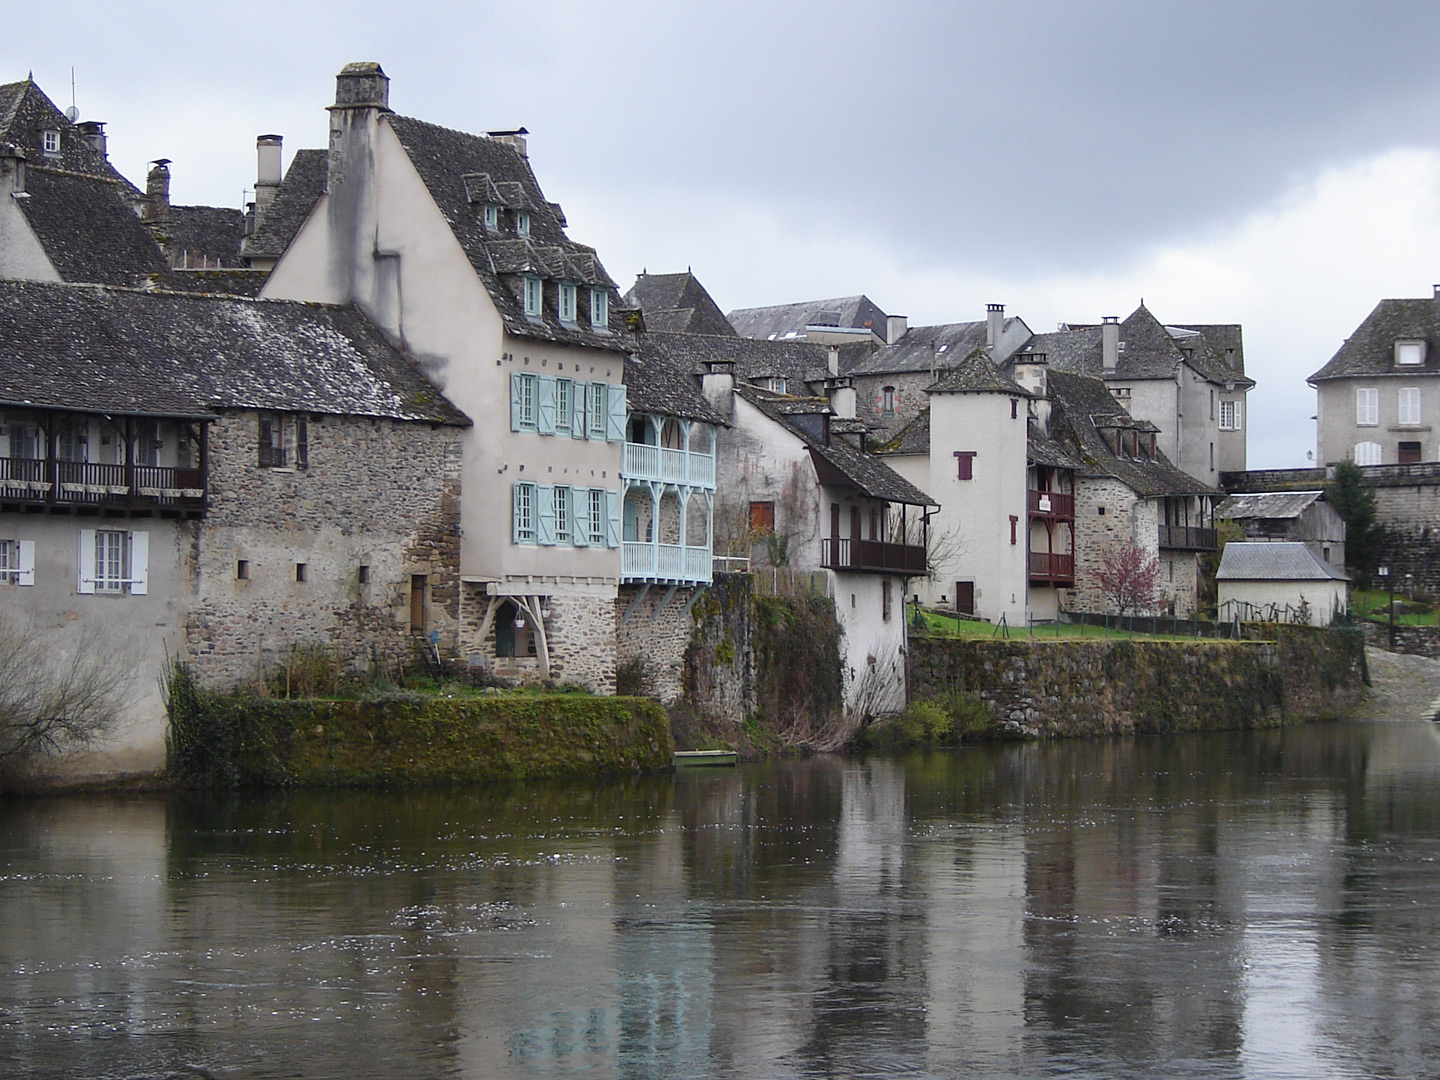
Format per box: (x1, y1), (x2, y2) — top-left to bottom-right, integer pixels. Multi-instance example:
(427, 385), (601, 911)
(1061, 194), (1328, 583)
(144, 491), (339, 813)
(249, 63), (634, 691)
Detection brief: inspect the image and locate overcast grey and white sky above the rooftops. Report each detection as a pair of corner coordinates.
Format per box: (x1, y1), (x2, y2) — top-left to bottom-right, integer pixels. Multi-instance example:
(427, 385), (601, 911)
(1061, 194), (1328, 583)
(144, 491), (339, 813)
(8, 0), (1440, 468)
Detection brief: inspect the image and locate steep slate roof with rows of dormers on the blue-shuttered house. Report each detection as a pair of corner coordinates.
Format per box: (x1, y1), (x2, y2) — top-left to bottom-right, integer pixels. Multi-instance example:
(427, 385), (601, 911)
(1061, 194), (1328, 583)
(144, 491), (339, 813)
(382, 114), (629, 350)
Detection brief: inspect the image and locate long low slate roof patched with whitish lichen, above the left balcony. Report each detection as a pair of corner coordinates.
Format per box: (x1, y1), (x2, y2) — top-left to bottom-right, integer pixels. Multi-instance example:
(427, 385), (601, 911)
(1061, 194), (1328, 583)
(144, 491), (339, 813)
(0, 281), (469, 425)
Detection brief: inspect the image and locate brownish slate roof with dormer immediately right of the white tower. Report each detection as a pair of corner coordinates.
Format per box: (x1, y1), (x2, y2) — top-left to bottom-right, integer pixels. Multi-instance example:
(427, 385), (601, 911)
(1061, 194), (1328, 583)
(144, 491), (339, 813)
(1048, 370), (1220, 498)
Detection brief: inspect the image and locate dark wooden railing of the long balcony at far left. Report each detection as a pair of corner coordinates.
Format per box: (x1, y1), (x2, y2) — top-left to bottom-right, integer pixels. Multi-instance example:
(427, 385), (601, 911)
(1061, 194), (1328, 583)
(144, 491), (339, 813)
(0, 458), (206, 511)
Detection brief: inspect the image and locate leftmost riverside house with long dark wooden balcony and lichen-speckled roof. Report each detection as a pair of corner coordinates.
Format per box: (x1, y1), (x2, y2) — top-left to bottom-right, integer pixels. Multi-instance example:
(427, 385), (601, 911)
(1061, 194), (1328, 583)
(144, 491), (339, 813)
(0, 282), (468, 772)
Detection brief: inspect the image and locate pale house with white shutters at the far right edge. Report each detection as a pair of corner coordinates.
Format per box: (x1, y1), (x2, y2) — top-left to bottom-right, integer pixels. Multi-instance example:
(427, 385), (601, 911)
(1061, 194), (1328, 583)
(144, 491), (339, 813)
(1308, 285), (1440, 465)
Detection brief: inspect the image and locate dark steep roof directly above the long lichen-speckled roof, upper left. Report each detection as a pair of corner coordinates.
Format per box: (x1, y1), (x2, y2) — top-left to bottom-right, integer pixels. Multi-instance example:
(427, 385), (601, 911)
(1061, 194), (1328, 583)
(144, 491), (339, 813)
(16, 164), (168, 285)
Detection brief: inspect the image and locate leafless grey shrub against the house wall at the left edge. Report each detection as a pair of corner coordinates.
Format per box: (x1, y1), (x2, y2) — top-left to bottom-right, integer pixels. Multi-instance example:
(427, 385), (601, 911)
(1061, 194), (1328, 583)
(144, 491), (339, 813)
(0, 612), (135, 783)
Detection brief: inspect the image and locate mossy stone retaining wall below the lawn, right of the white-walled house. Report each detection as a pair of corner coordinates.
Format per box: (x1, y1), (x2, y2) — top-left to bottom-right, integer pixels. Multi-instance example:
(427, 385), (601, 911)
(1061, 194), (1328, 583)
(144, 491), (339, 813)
(910, 626), (1365, 736)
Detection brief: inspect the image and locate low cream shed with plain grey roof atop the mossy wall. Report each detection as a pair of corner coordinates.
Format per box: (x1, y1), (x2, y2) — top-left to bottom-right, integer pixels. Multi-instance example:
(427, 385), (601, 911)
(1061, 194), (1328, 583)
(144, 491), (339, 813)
(1215, 540), (1349, 626)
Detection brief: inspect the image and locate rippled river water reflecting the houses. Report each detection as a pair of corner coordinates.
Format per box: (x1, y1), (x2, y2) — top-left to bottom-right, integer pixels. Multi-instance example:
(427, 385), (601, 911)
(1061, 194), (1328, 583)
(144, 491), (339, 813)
(0, 723), (1440, 1079)
